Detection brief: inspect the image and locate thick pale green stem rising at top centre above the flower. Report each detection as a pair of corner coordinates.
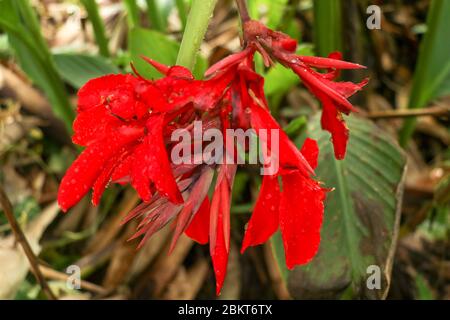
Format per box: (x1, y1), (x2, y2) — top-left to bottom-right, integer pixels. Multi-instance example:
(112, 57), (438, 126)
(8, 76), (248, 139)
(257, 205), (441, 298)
(177, 0), (217, 70)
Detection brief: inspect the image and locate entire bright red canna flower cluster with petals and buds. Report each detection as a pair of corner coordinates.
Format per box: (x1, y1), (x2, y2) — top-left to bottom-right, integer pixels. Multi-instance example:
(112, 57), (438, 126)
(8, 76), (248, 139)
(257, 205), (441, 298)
(58, 21), (365, 293)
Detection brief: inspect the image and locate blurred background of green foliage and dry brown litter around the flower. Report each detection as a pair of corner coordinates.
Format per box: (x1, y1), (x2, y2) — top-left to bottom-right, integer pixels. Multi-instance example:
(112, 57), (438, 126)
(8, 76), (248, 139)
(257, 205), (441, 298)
(0, 0), (450, 299)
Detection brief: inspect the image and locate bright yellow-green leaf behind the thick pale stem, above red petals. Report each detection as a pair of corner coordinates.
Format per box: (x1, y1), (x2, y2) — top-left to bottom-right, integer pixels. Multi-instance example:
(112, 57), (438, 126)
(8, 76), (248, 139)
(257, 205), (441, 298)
(128, 28), (207, 79)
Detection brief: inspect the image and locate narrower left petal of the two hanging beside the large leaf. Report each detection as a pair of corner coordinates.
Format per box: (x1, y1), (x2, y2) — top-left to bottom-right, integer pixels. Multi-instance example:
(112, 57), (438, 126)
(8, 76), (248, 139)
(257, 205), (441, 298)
(241, 176), (280, 253)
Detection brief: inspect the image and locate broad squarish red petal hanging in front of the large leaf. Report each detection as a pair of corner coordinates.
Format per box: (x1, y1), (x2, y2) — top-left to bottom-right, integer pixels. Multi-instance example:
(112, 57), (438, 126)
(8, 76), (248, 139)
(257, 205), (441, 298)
(280, 172), (325, 269)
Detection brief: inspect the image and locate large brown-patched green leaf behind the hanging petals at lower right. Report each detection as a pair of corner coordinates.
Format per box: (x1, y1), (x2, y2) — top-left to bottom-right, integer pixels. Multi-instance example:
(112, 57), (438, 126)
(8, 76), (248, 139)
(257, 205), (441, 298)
(272, 116), (405, 299)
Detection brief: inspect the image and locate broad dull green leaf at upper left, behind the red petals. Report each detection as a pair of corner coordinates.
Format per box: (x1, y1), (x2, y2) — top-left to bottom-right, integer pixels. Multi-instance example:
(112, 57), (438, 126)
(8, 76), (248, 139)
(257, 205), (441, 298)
(53, 53), (120, 89)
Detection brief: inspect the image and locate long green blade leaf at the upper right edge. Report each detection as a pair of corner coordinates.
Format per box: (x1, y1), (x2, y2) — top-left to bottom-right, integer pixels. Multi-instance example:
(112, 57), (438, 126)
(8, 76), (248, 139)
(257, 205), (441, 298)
(400, 0), (450, 146)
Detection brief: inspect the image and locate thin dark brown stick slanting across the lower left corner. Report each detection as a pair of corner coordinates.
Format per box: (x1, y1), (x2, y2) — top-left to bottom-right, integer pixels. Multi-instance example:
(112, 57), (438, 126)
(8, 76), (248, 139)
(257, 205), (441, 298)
(0, 186), (56, 300)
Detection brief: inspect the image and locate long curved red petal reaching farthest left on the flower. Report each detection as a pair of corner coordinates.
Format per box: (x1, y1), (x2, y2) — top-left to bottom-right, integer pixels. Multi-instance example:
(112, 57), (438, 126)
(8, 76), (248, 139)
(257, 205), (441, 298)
(58, 127), (143, 211)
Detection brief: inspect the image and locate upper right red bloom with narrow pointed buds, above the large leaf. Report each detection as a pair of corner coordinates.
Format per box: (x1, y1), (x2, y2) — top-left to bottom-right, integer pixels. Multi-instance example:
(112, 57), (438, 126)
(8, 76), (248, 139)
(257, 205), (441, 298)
(244, 20), (368, 159)
